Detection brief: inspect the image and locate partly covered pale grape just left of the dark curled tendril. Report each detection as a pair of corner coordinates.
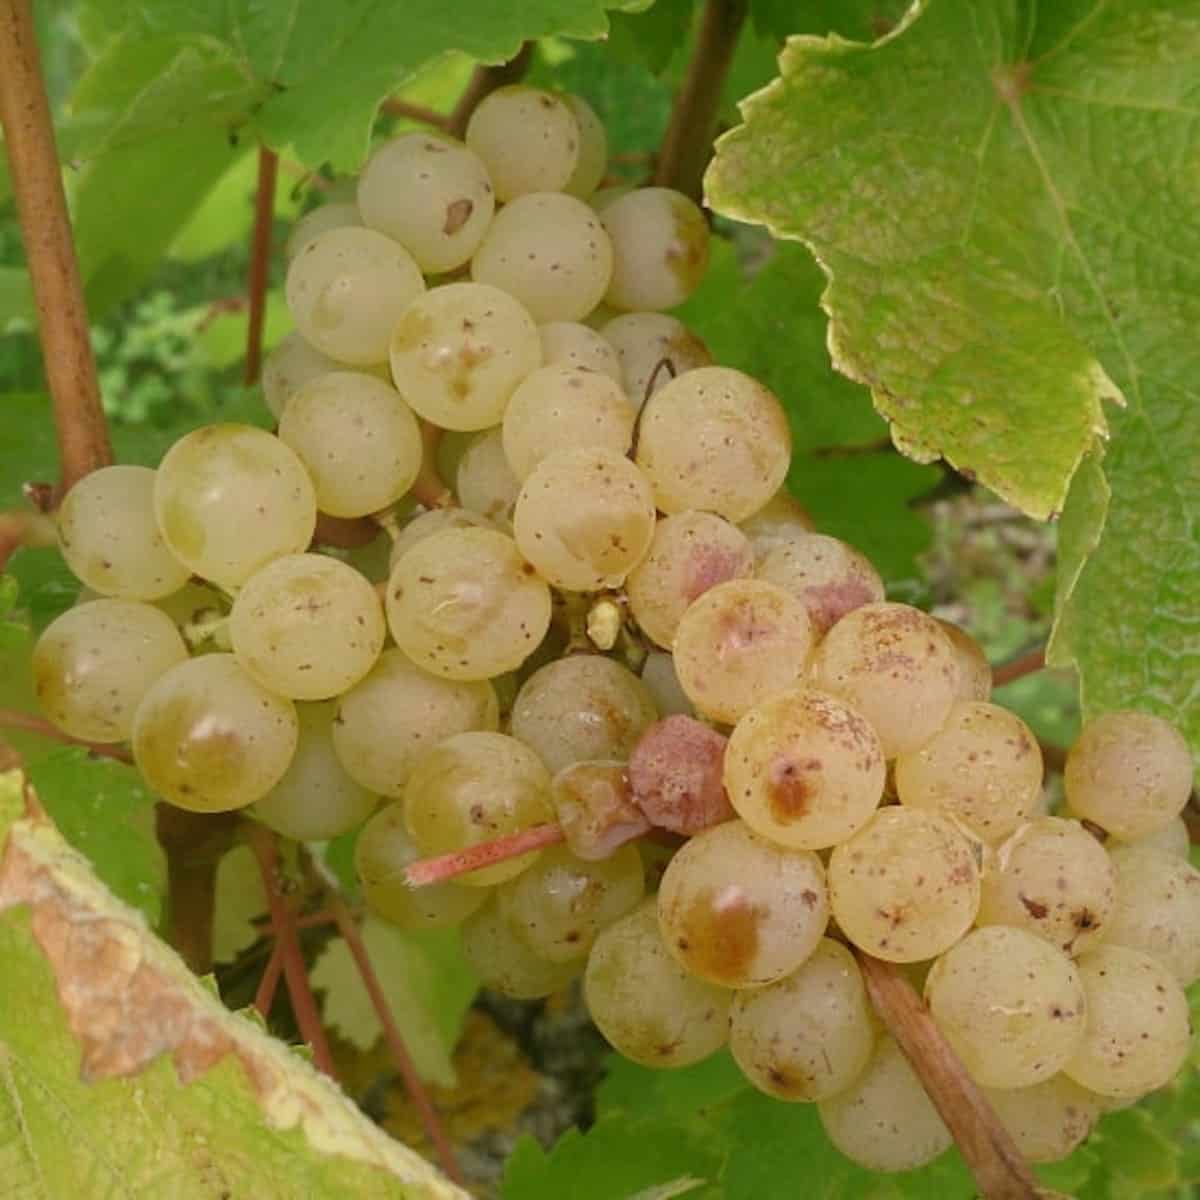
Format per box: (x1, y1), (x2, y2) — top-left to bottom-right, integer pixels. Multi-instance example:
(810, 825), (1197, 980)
(499, 367), (637, 481)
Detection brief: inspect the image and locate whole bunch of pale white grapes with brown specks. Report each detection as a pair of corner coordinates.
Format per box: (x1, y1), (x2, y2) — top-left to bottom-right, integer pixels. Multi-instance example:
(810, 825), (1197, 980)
(34, 85), (1200, 1170)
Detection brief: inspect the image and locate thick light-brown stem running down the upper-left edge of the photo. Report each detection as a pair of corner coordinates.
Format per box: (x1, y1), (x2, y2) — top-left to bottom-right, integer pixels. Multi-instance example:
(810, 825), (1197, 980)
(0, 0), (113, 496)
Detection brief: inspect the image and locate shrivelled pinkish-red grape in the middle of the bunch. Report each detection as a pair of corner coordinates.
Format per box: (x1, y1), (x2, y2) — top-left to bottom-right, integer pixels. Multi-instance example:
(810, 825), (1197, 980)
(629, 714), (734, 836)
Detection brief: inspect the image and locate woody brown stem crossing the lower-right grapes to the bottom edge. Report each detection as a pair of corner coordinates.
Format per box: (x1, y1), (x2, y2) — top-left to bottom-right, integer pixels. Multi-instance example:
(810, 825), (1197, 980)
(854, 949), (1040, 1200)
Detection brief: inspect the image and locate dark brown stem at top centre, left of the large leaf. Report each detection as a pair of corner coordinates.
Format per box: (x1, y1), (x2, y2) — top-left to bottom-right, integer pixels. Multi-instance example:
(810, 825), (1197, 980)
(654, 0), (749, 202)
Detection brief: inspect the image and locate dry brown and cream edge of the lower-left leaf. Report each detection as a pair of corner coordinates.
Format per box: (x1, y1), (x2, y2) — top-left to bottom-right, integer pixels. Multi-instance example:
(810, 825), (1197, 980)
(0, 770), (468, 1200)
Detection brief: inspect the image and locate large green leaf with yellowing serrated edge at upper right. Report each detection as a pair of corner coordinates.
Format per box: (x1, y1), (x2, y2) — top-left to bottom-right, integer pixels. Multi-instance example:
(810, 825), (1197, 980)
(708, 0), (1200, 757)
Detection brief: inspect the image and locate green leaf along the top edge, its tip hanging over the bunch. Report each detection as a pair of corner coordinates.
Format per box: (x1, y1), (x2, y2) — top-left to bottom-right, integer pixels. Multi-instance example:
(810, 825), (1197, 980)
(88, 0), (644, 170)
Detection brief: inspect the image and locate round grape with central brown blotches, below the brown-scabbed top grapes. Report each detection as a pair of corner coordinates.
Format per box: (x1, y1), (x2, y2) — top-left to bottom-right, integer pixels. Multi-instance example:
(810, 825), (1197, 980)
(388, 283), (541, 432)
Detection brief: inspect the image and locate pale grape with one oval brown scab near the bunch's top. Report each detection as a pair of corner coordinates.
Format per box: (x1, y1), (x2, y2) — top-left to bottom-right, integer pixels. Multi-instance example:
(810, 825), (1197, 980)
(358, 132), (496, 275)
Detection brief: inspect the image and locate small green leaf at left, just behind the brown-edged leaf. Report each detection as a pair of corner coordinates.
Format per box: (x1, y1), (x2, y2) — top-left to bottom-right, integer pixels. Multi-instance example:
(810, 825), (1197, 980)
(28, 746), (167, 925)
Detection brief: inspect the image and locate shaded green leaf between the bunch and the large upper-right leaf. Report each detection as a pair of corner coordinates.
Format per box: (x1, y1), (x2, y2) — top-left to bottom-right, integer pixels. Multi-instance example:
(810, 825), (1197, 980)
(677, 239), (940, 590)
